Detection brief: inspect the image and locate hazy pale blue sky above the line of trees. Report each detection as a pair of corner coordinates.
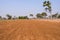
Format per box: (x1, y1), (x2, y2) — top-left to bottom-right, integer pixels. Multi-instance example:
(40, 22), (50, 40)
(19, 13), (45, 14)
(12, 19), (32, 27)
(0, 0), (60, 16)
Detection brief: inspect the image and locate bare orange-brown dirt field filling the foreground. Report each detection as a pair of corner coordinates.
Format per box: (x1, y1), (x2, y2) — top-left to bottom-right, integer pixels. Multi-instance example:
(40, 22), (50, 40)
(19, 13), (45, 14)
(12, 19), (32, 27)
(0, 19), (60, 40)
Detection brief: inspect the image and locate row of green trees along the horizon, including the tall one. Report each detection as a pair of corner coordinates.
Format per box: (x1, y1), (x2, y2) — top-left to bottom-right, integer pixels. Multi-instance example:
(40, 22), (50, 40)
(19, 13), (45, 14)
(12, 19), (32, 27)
(0, 1), (60, 19)
